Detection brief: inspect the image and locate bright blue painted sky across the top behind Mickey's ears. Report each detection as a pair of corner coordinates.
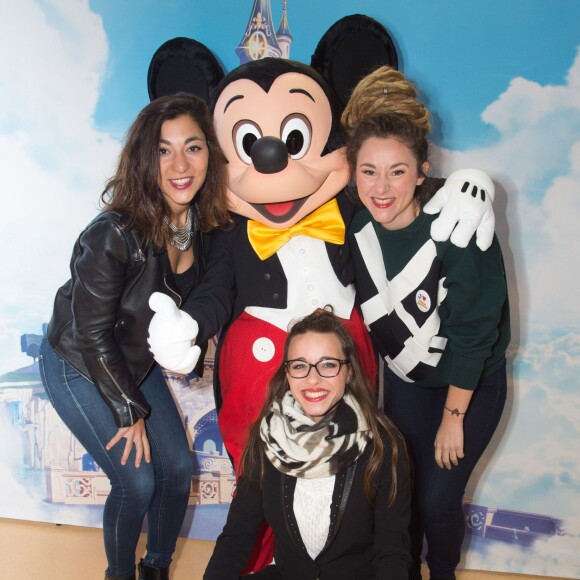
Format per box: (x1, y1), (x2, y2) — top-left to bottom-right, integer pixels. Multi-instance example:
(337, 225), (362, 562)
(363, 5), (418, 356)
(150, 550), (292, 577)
(89, 0), (580, 148)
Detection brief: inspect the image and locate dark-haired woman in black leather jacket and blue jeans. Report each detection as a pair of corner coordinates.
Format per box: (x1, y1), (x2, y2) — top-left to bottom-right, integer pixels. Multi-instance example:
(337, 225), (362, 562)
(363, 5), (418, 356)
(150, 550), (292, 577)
(40, 93), (229, 580)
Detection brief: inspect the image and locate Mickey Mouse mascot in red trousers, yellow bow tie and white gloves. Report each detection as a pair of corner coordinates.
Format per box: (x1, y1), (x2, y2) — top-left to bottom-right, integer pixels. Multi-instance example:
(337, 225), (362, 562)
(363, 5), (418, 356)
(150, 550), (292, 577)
(149, 15), (493, 569)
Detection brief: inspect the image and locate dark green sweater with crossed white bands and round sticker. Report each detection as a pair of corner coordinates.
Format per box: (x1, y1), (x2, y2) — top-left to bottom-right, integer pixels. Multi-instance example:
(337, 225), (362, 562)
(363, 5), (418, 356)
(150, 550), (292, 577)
(349, 209), (510, 389)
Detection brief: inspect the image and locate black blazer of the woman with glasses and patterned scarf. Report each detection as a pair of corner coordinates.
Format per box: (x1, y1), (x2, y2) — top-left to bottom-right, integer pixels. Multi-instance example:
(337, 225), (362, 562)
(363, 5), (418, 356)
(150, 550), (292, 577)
(203, 442), (411, 580)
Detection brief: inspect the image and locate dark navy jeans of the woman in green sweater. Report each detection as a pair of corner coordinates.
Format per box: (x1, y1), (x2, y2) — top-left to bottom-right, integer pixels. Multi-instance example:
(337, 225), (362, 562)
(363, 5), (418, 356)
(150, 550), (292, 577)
(384, 361), (507, 578)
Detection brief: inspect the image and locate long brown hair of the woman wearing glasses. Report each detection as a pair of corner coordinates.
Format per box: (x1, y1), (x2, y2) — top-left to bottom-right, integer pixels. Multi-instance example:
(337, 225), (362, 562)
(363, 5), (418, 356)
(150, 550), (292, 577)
(240, 307), (408, 505)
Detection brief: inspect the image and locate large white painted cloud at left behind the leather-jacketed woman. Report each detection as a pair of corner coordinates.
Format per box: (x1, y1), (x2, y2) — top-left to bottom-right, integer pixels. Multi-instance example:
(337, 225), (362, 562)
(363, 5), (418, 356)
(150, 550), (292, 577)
(0, 0), (118, 374)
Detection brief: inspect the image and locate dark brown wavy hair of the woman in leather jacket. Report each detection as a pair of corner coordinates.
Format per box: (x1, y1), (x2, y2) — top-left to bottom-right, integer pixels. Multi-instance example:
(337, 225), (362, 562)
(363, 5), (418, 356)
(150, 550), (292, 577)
(101, 93), (232, 248)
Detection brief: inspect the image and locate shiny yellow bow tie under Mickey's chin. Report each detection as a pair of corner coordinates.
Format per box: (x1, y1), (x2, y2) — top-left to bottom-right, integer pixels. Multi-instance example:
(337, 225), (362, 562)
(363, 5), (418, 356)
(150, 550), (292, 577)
(248, 199), (345, 260)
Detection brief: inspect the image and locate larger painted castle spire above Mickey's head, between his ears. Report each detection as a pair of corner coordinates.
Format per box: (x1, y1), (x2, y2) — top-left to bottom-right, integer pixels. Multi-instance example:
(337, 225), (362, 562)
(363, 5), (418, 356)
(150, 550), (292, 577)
(236, 0), (282, 64)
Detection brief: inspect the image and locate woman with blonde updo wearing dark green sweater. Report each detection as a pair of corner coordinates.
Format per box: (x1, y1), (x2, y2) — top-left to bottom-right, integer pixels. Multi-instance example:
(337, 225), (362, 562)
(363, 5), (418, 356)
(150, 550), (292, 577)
(343, 67), (510, 580)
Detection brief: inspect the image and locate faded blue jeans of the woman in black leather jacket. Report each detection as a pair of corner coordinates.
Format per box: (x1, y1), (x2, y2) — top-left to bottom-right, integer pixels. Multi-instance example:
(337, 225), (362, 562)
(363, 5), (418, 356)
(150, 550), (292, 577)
(39, 339), (192, 577)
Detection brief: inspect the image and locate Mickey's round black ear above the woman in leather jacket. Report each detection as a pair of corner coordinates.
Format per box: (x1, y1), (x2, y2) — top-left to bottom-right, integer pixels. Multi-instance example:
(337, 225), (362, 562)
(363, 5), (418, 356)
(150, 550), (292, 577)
(147, 37), (224, 103)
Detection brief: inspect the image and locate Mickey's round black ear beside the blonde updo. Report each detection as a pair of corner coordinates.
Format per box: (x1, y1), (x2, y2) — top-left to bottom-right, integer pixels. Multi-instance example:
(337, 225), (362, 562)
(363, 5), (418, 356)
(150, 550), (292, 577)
(310, 14), (399, 107)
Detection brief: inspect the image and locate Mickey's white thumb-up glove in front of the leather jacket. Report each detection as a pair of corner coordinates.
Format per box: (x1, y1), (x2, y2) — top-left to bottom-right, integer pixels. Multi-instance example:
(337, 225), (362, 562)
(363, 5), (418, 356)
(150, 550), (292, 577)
(147, 292), (201, 375)
